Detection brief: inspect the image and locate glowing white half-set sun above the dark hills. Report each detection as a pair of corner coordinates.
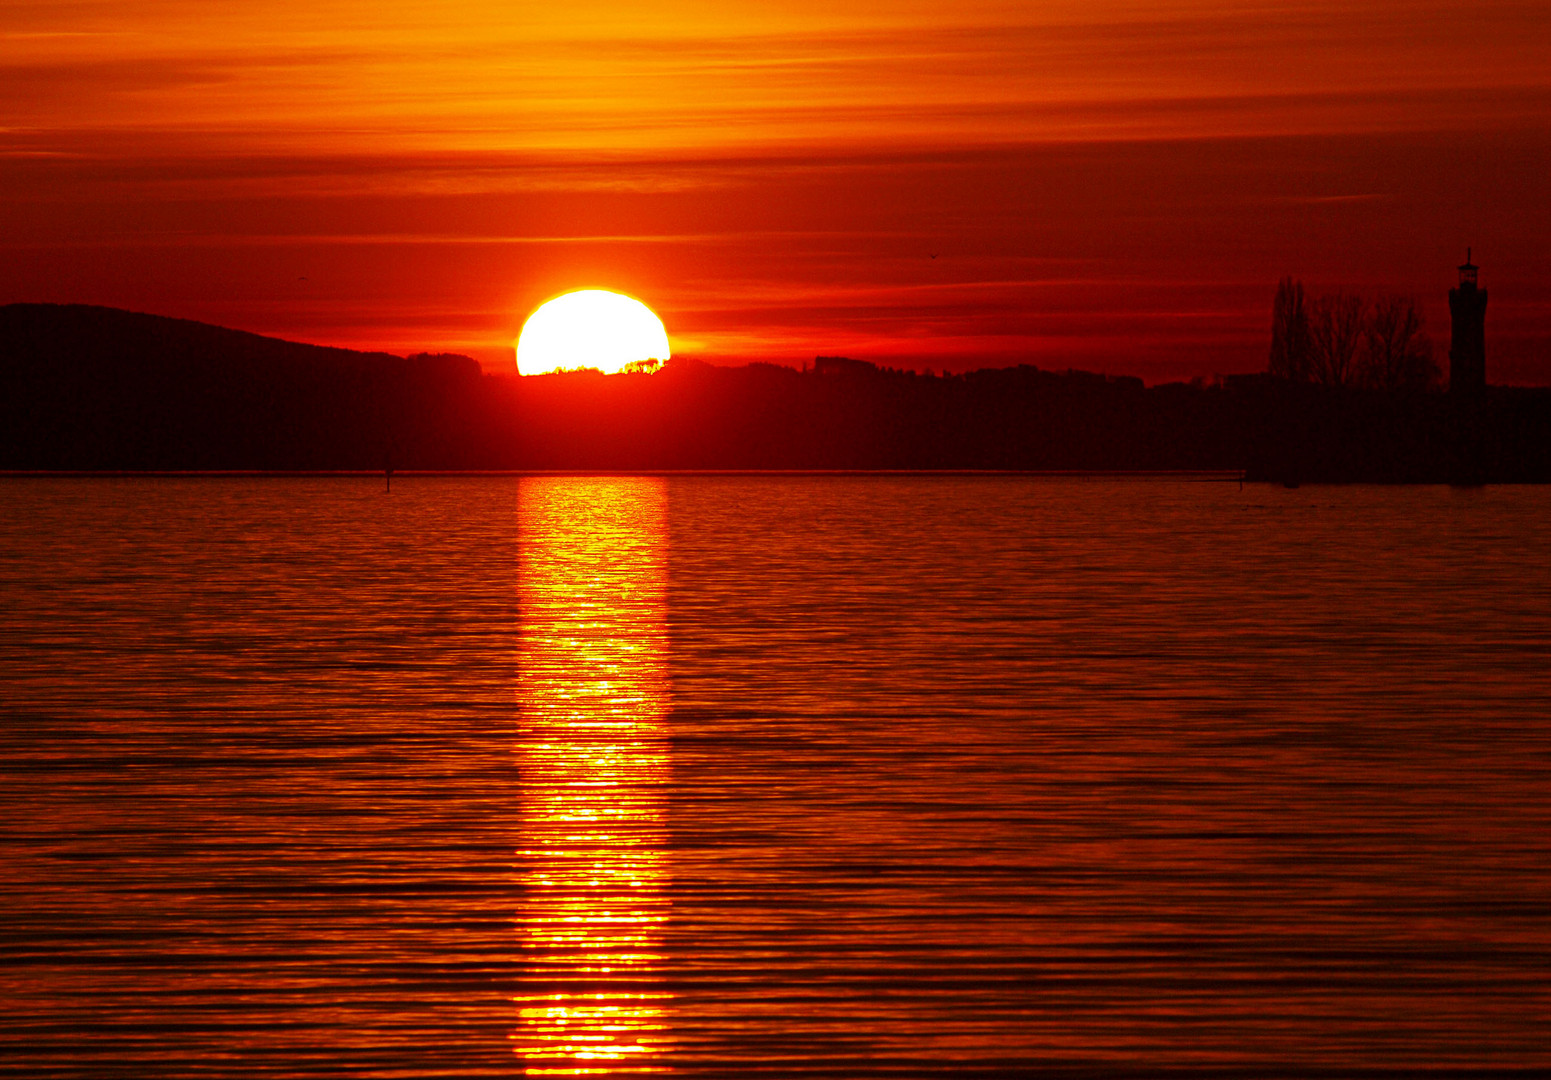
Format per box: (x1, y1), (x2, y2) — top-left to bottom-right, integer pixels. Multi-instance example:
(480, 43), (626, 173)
(516, 289), (668, 376)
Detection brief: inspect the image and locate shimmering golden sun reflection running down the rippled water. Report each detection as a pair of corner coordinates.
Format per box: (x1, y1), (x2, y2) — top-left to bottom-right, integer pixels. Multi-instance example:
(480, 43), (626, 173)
(513, 478), (668, 1075)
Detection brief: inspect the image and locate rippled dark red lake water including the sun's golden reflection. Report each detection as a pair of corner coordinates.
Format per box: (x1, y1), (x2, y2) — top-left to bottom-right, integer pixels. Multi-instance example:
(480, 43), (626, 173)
(0, 476), (1551, 1077)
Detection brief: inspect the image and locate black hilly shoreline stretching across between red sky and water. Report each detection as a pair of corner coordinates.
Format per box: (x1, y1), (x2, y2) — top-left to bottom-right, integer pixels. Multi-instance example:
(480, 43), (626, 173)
(0, 304), (1551, 483)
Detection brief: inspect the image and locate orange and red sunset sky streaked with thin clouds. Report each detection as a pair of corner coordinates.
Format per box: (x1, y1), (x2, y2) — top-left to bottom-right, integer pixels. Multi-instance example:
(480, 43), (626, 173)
(0, 0), (1551, 385)
